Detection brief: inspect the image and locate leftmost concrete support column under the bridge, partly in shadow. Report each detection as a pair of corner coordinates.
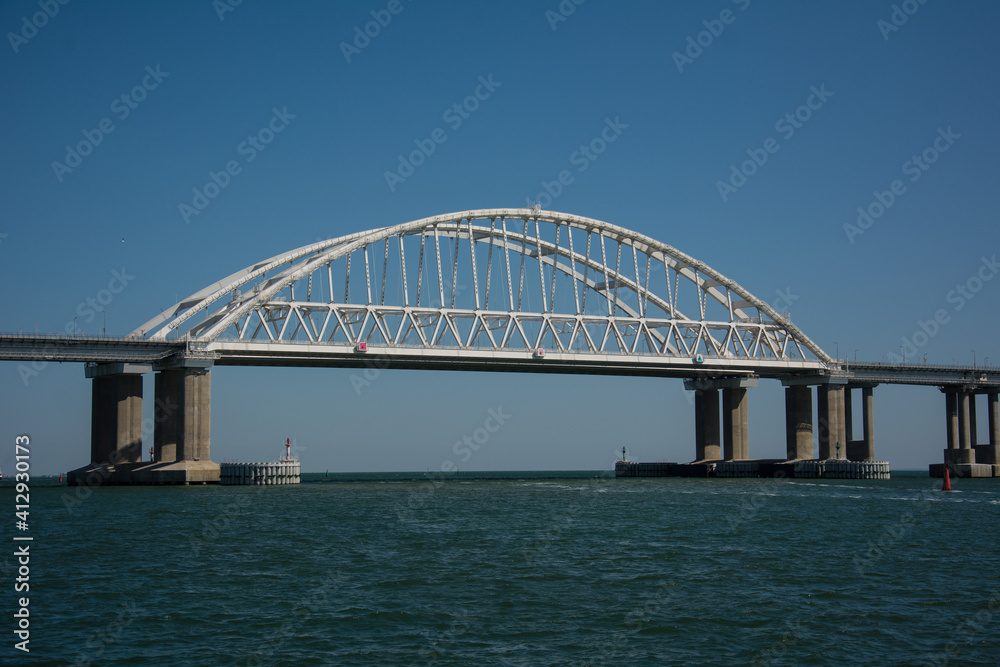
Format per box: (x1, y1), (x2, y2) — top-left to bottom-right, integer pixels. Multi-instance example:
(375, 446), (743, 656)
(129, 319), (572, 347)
(90, 375), (142, 463)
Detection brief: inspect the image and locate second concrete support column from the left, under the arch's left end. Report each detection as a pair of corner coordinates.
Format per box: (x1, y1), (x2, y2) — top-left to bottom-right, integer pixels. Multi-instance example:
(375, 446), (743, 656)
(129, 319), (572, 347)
(153, 368), (212, 462)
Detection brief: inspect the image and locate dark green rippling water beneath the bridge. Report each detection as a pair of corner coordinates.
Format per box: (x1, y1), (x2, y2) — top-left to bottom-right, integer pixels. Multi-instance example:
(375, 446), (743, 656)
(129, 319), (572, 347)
(0, 473), (1000, 665)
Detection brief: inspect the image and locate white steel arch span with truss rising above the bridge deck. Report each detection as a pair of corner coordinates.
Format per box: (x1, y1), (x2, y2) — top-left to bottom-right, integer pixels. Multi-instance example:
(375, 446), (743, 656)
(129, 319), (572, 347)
(131, 208), (835, 374)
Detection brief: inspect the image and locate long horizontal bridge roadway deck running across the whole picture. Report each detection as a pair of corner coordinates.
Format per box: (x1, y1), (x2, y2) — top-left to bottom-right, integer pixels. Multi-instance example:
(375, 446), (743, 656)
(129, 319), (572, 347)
(7, 333), (1000, 380)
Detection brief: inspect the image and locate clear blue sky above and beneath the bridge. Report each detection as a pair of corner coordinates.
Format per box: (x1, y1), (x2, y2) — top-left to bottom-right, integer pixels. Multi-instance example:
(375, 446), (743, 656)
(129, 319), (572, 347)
(0, 0), (1000, 474)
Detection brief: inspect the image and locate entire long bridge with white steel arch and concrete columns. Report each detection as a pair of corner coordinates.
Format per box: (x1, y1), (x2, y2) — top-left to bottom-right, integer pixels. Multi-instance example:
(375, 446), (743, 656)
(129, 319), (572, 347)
(0, 208), (1000, 483)
